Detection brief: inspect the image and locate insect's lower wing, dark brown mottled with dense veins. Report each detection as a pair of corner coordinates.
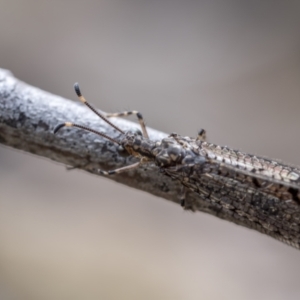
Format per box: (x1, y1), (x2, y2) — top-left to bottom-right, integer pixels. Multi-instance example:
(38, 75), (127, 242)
(164, 152), (300, 248)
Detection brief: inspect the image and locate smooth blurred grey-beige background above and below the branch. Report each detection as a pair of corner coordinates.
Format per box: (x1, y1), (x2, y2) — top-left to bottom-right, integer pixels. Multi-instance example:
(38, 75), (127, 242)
(0, 0), (300, 300)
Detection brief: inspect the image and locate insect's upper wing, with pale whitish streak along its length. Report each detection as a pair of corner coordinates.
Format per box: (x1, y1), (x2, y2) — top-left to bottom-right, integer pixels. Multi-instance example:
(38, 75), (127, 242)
(199, 142), (300, 204)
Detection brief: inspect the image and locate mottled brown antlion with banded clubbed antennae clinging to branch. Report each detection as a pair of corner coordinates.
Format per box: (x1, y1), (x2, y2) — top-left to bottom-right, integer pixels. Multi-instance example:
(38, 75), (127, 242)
(54, 83), (300, 248)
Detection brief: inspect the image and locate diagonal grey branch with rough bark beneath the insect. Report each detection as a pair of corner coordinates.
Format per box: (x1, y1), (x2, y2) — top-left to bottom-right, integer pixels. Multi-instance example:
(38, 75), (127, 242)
(0, 69), (296, 248)
